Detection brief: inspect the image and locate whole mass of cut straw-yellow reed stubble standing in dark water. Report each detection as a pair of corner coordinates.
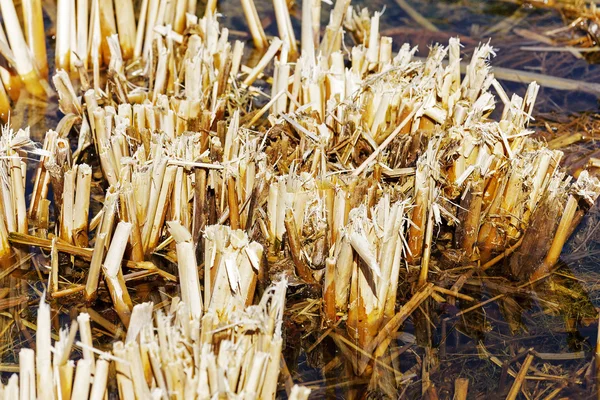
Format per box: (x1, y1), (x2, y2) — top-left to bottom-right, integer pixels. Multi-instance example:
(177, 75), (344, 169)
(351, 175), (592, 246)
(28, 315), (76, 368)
(0, 0), (600, 399)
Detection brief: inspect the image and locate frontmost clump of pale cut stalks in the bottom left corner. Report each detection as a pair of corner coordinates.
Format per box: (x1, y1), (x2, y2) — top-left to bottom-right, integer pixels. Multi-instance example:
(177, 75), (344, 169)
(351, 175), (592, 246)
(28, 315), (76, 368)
(0, 282), (310, 400)
